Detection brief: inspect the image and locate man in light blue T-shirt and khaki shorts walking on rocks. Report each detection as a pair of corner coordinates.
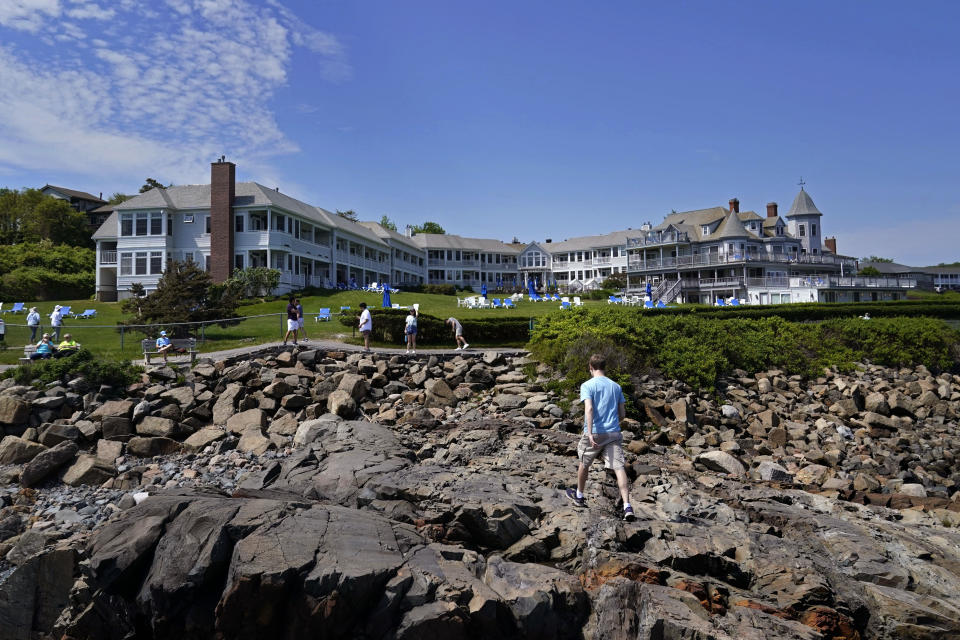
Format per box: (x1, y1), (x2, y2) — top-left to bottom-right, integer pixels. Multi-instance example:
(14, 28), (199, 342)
(567, 353), (634, 521)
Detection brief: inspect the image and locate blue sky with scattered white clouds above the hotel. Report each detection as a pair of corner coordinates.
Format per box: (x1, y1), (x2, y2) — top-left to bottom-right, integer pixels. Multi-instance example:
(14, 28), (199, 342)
(0, 0), (960, 264)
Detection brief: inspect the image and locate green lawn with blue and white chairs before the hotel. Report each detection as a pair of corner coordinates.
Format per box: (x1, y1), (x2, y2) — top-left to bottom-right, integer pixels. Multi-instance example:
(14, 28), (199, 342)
(0, 291), (607, 364)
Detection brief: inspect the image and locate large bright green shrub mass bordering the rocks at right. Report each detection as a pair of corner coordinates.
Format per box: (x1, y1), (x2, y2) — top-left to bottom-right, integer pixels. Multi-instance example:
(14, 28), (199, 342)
(528, 307), (960, 389)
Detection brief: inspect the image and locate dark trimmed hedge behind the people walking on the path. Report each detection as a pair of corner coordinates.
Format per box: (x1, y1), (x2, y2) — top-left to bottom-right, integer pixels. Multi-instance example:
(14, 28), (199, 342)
(340, 308), (530, 345)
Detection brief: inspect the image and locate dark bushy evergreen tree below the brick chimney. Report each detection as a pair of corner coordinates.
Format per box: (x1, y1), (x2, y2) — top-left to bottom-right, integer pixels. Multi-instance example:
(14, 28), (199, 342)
(121, 261), (240, 337)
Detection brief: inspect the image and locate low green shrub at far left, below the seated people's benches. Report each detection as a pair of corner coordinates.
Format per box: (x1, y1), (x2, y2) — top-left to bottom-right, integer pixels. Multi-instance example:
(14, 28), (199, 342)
(0, 349), (143, 392)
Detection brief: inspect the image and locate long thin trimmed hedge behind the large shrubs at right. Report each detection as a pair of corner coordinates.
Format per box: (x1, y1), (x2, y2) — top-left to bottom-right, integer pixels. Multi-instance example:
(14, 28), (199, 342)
(625, 300), (960, 322)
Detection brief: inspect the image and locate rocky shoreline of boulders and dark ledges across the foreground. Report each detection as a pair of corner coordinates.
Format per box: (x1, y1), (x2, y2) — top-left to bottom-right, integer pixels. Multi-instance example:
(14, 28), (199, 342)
(0, 349), (960, 640)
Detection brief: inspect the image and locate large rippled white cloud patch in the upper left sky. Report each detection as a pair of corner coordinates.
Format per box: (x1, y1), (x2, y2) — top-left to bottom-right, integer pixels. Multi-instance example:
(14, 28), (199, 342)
(0, 0), (350, 183)
